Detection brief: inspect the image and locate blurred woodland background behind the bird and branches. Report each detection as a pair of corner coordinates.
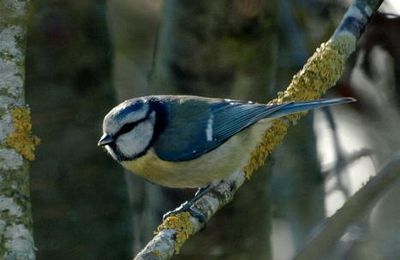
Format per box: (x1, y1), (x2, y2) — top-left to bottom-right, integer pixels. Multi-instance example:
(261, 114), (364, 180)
(26, 0), (400, 260)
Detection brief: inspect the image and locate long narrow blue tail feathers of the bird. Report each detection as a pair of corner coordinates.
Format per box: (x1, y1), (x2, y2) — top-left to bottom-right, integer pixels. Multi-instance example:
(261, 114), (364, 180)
(269, 97), (357, 118)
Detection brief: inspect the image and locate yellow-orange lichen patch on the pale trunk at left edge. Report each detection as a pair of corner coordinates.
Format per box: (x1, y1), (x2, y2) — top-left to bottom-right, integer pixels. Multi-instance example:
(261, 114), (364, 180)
(5, 107), (40, 161)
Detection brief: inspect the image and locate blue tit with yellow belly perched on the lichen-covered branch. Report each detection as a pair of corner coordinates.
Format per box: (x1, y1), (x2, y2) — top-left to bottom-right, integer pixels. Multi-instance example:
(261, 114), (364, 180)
(98, 95), (355, 217)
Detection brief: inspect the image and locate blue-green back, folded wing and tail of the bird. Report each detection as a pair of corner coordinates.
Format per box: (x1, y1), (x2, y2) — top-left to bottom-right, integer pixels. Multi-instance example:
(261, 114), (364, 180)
(153, 97), (355, 161)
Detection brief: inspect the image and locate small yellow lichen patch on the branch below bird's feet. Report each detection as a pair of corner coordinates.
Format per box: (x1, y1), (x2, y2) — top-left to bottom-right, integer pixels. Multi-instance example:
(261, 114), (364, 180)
(155, 212), (196, 254)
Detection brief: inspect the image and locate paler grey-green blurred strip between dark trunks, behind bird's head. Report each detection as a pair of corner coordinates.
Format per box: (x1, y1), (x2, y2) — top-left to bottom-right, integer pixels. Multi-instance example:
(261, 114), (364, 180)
(107, 0), (163, 254)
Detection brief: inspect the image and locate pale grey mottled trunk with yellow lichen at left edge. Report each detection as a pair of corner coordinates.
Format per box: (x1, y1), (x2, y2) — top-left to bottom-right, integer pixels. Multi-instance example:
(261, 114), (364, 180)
(0, 0), (35, 260)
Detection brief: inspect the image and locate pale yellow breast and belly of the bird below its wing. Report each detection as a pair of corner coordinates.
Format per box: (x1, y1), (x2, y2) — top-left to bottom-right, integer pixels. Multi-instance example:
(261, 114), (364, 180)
(121, 121), (271, 188)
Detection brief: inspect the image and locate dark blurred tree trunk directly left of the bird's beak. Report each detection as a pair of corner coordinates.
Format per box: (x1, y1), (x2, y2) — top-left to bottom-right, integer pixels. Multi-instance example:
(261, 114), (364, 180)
(27, 0), (132, 259)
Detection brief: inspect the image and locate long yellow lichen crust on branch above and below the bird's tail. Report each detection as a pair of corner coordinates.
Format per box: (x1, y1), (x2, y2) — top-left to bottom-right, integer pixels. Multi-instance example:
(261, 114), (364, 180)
(243, 35), (355, 178)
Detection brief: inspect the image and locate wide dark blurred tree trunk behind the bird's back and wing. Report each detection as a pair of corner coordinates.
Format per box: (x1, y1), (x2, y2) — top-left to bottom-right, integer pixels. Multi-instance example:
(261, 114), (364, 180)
(151, 0), (277, 259)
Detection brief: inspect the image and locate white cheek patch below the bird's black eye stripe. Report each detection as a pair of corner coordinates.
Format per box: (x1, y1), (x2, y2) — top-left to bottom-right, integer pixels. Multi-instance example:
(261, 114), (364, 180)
(116, 116), (153, 158)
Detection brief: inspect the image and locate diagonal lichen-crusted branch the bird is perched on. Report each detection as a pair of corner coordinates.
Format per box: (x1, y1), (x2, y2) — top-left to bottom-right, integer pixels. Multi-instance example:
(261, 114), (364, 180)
(135, 0), (382, 259)
